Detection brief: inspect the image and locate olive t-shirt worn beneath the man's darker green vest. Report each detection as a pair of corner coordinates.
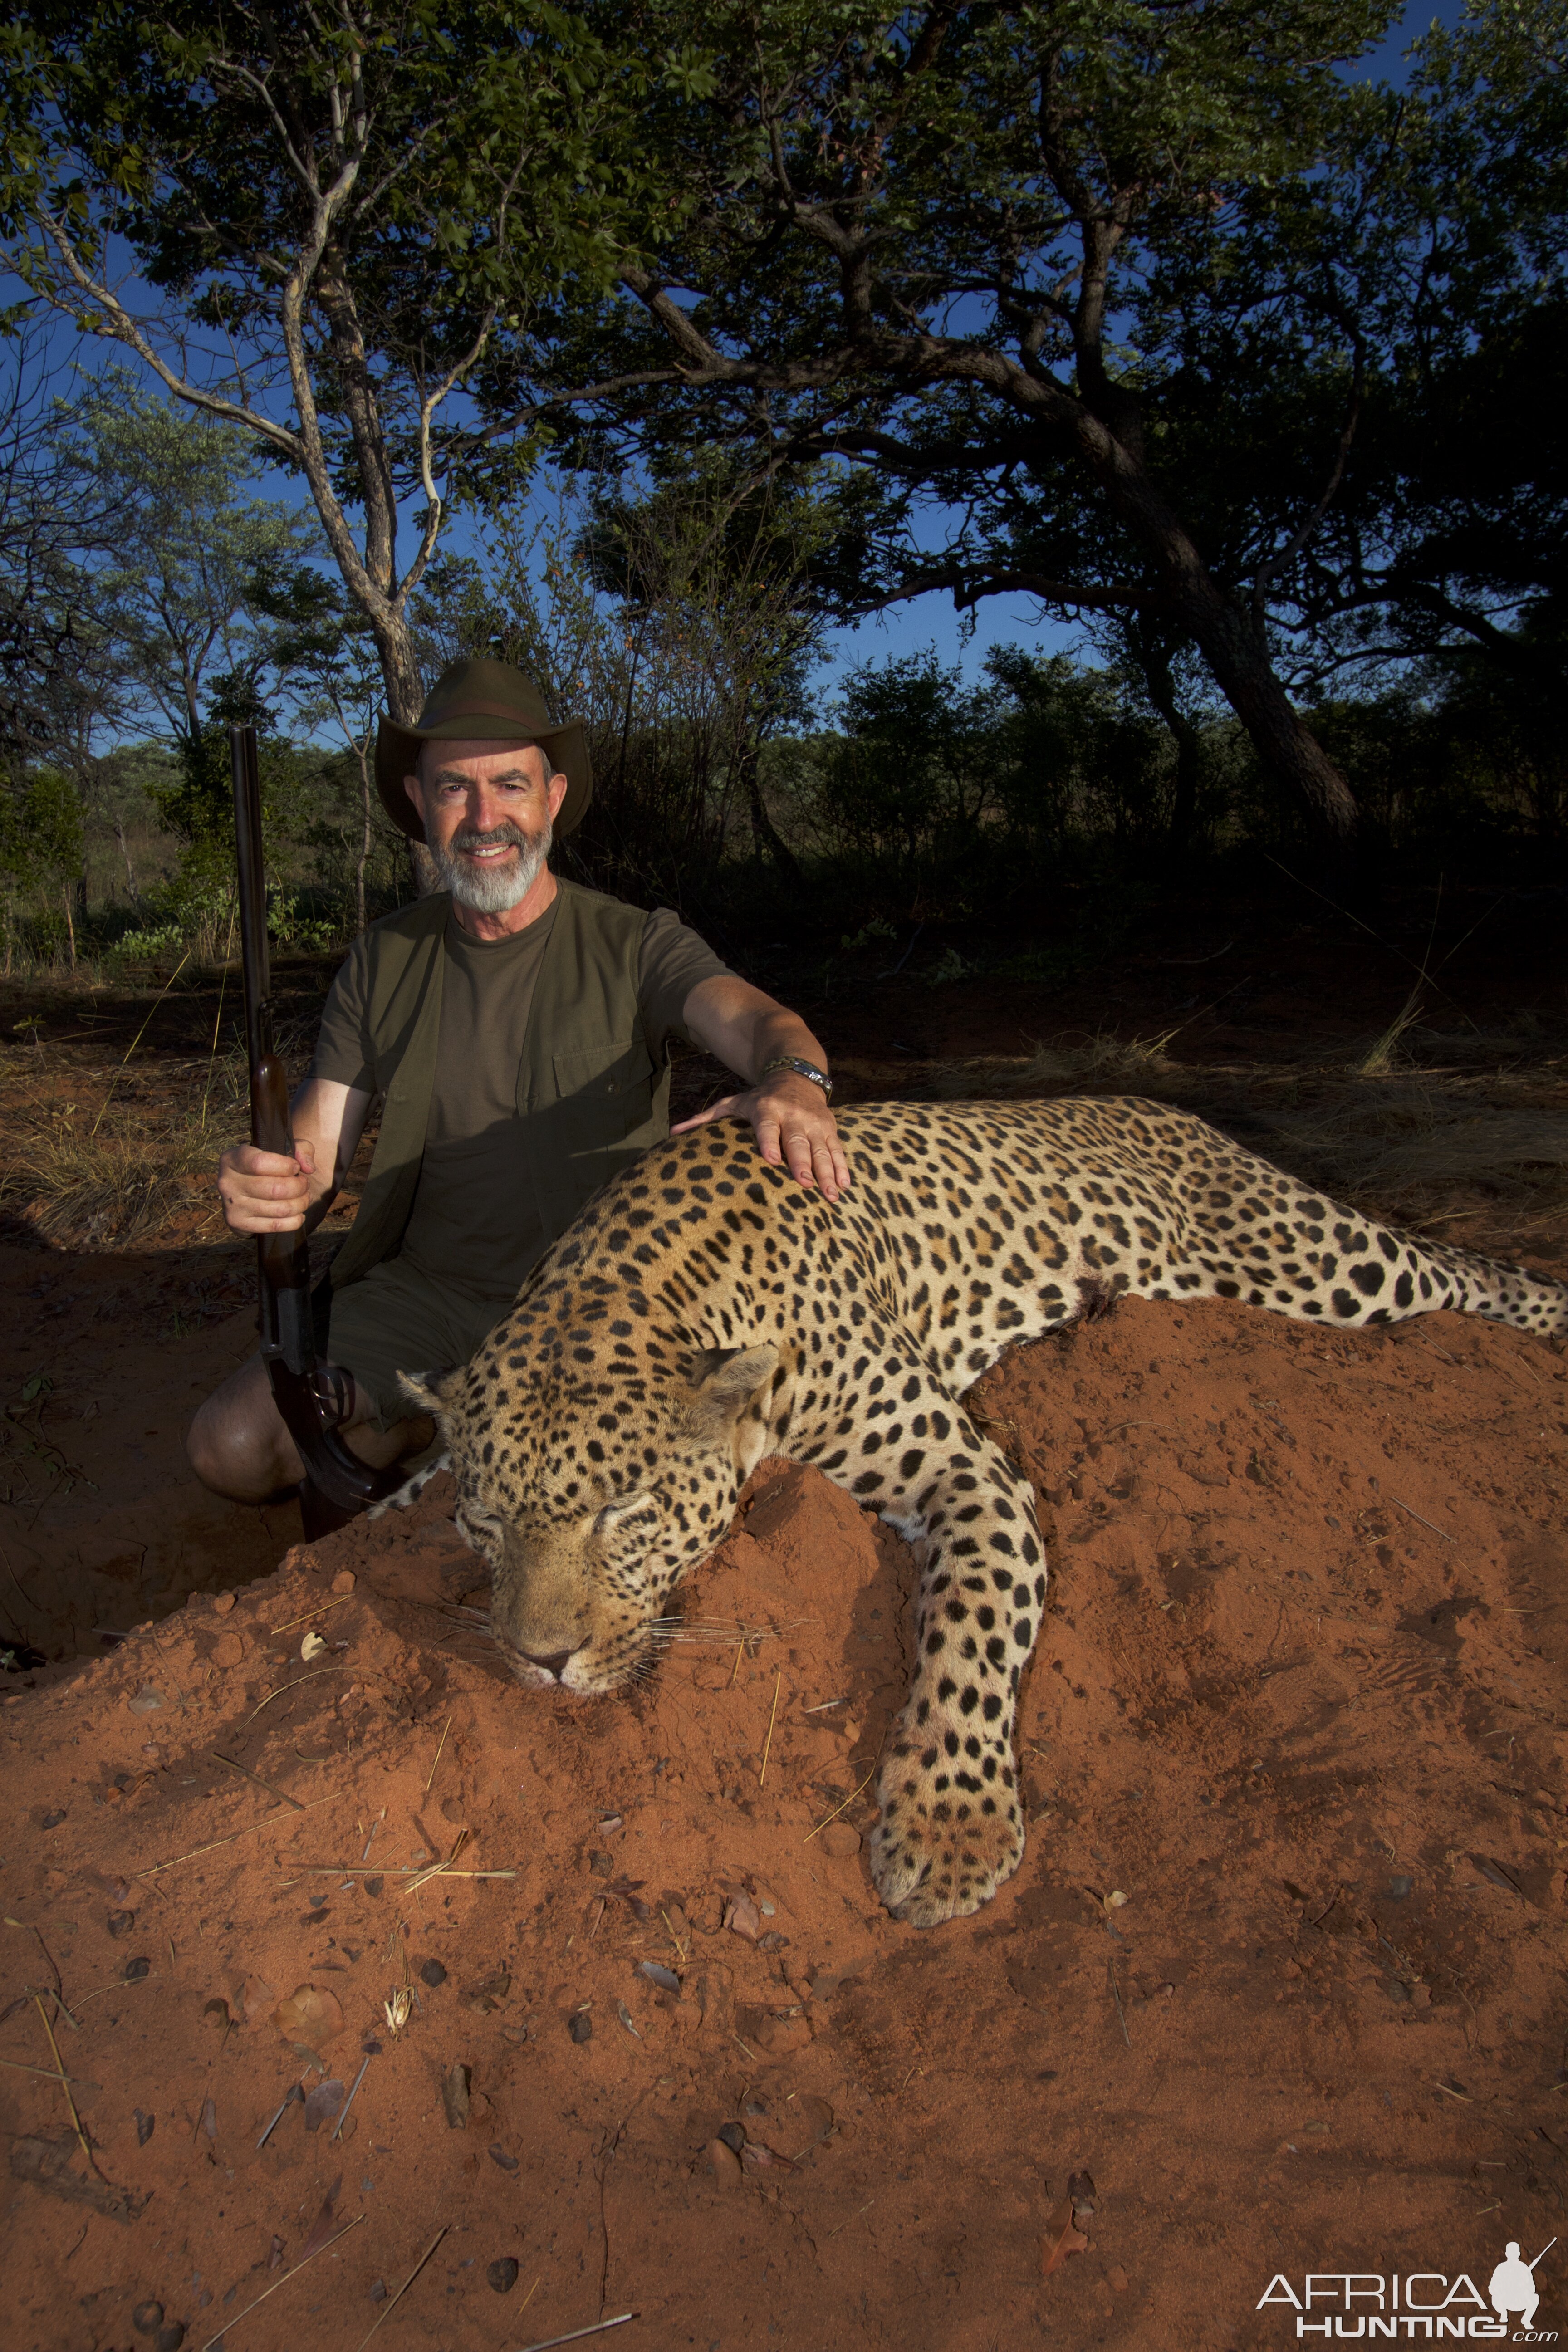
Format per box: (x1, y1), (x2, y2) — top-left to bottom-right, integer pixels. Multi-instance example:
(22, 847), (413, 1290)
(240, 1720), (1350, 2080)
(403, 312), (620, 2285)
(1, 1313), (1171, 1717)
(310, 901), (729, 1305)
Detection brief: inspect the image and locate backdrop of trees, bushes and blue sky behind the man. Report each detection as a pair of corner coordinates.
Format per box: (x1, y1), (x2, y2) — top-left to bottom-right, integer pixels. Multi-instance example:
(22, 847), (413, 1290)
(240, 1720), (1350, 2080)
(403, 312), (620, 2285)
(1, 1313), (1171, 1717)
(0, 0), (1568, 969)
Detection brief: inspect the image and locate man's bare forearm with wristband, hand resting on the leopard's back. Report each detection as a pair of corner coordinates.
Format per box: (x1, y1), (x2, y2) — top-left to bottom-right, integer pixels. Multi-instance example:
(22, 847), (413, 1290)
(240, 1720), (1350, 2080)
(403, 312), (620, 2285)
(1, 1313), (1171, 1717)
(670, 974), (848, 1200)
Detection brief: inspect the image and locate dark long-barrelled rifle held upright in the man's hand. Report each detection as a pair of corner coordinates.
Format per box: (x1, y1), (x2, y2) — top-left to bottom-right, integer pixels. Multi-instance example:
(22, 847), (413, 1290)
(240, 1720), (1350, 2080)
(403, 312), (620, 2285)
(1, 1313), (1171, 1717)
(228, 727), (402, 1541)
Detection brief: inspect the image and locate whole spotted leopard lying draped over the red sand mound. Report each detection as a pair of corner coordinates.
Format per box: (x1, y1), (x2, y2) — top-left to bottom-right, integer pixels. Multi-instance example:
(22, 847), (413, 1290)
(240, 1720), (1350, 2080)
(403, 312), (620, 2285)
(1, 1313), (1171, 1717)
(404, 1101), (1568, 1926)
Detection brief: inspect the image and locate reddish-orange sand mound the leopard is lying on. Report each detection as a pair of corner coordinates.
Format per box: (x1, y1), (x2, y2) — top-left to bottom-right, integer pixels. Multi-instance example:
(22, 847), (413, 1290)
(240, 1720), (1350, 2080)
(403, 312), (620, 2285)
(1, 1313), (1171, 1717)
(0, 1303), (1568, 2352)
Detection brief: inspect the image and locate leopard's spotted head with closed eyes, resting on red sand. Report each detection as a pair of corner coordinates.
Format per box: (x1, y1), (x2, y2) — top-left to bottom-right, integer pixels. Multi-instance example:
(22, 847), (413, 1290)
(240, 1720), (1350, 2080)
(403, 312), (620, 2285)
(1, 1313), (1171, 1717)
(400, 1324), (778, 1693)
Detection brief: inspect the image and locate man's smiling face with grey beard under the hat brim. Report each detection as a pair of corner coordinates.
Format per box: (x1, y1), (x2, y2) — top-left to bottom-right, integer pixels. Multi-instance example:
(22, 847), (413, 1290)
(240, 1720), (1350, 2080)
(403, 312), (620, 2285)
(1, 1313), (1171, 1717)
(404, 741), (567, 915)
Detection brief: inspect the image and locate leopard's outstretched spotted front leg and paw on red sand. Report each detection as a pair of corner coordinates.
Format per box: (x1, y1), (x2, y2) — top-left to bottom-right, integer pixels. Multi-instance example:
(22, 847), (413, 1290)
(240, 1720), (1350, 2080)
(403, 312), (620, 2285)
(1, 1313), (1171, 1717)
(870, 1423), (1046, 1926)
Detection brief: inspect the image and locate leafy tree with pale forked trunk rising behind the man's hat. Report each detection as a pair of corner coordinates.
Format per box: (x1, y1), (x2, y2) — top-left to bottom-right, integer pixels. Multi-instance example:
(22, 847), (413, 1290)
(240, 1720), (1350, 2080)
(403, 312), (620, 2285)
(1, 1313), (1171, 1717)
(0, 0), (696, 717)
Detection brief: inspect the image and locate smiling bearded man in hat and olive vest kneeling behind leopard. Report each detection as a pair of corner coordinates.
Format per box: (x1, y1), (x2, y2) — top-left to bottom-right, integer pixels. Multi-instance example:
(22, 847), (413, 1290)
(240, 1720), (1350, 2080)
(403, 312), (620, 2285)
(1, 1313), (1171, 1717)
(186, 661), (848, 1503)
